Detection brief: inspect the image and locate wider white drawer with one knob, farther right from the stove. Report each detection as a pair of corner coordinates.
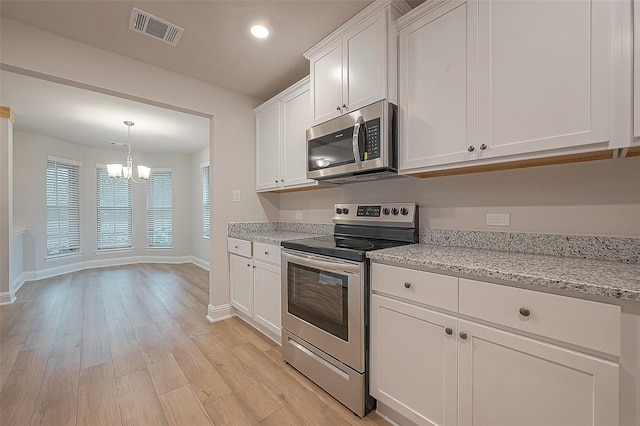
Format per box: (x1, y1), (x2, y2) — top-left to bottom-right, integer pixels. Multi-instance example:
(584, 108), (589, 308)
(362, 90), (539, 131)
(460, 278), (620, 356)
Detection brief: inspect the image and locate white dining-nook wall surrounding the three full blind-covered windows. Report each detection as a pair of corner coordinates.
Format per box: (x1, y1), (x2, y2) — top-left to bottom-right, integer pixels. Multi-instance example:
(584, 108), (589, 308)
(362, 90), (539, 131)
(13, 132), (193, 276)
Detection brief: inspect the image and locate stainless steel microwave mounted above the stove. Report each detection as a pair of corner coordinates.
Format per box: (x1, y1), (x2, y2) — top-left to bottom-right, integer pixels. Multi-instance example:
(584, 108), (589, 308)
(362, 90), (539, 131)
(307, 100), (398, 184)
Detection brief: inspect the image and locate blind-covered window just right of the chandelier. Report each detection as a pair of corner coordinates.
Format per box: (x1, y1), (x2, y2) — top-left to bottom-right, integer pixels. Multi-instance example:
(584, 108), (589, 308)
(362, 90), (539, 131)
(147, 170), (173, 247)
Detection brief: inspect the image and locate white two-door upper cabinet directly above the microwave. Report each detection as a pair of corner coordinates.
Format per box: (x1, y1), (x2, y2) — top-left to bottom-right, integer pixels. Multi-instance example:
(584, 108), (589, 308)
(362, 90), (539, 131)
(304, 0), (409, 125)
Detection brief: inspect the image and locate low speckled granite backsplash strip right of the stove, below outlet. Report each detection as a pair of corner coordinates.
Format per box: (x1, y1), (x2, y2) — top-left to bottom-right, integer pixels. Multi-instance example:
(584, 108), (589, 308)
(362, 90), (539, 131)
(420, 228), (640, 263)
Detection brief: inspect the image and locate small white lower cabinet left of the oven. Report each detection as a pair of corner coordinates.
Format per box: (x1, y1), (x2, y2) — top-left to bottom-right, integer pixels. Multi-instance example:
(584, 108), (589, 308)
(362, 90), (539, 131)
(228, 238), (281, 342)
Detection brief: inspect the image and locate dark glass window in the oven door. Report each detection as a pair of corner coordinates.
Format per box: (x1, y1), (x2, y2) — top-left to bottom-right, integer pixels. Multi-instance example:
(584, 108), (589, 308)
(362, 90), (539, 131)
(287, 263), (349, 342)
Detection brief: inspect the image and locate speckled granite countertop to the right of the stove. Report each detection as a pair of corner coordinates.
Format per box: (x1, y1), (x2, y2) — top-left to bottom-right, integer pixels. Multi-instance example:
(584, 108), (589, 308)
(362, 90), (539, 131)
(367, 244), (640, 302)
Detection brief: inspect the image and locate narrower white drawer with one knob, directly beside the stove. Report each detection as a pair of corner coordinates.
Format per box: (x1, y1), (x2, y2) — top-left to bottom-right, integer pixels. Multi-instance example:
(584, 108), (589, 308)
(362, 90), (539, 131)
(371, 263), (458, 312)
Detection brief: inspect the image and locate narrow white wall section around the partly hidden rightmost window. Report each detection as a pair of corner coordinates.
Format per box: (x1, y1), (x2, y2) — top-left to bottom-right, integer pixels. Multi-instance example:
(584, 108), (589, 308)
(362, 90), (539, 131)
(191, 147), (211, 268)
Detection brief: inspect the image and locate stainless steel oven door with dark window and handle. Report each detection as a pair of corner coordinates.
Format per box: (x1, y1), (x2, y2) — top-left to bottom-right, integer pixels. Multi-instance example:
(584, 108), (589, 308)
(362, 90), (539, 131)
(282, 249), (366, 372)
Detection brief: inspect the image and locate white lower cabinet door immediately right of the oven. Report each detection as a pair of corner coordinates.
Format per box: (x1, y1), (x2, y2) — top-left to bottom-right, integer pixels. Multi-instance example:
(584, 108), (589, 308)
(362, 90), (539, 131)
(369, 294), (457, 425)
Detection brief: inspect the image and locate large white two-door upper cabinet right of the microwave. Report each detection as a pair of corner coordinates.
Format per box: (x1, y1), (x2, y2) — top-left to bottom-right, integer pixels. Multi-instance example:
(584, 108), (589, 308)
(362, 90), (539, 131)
(398, 0), (631, 173)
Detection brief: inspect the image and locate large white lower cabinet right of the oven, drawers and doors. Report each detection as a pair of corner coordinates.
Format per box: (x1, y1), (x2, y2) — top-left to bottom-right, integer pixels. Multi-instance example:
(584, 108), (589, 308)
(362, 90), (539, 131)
(369, 264), (620, 426)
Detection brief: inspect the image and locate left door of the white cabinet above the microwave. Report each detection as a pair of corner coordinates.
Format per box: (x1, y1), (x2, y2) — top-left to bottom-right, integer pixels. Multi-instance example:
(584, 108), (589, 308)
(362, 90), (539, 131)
(310, 40), (342, 124)
